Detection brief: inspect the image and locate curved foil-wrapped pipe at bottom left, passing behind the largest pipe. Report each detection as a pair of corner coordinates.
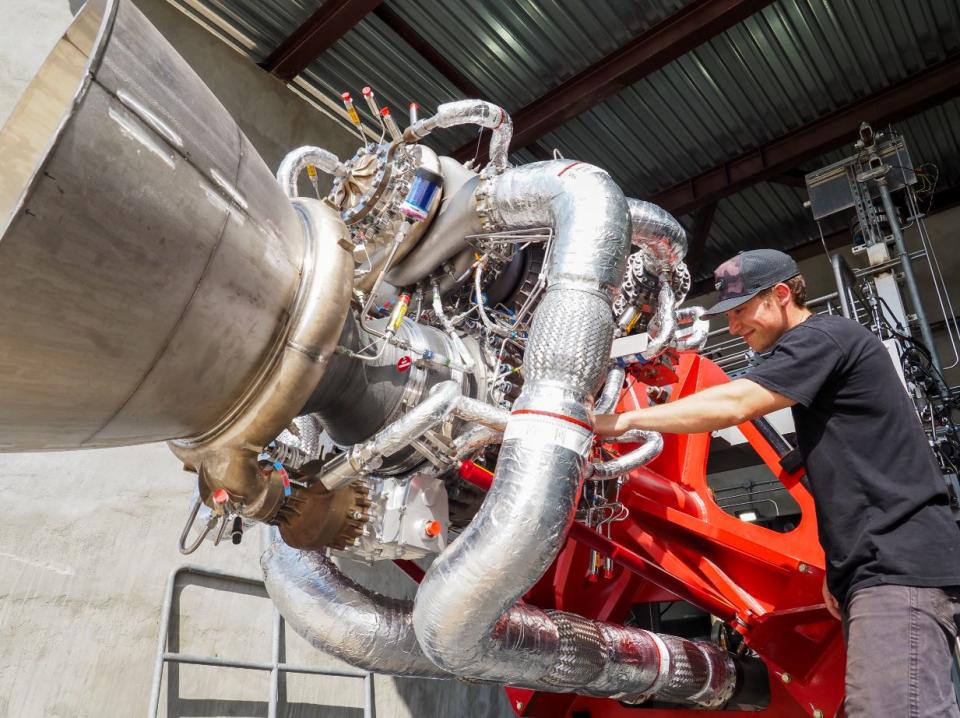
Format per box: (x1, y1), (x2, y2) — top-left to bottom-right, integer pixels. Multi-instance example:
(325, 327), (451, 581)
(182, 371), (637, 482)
(260, 540), (450, 678)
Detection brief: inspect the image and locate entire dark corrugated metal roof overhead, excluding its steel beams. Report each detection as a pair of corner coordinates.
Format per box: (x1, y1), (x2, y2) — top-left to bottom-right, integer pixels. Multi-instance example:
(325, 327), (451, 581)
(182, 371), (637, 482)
(177, 0), (960, 265)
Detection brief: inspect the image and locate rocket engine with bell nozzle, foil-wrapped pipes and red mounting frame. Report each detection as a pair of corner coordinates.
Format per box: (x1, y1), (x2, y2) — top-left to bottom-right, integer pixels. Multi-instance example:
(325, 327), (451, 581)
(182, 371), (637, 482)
(0, 0), (842, 715)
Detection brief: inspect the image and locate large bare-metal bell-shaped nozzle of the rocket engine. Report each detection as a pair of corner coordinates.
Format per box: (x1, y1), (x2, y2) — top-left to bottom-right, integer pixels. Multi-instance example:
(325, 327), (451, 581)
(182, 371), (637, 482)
(0, 0), (342, 462)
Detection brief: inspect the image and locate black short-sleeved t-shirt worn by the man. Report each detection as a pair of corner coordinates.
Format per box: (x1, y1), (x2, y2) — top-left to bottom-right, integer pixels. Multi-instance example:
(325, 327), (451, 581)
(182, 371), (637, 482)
(746, 315), (960, 605)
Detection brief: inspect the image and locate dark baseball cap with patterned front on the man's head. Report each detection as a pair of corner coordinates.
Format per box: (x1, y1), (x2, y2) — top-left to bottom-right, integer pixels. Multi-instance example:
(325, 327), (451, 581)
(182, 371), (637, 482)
(705, 249), (800, 315)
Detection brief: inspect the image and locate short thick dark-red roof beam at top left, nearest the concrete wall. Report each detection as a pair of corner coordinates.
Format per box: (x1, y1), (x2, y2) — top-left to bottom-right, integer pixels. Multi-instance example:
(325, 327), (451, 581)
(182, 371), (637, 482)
(260, 0), (382, 82)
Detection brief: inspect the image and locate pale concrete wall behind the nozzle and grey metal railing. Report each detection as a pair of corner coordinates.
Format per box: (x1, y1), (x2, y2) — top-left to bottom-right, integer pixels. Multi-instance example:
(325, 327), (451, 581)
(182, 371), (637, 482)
(0, 0), (512, 718)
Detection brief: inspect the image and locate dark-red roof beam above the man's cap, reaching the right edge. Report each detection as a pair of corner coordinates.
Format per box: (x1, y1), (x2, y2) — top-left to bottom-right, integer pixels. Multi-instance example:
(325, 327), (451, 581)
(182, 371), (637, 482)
(647, 54), (960, 215)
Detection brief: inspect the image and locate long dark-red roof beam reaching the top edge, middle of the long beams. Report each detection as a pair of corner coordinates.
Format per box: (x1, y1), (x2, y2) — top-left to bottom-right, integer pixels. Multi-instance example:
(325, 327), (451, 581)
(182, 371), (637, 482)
(453, 0), (773, 161)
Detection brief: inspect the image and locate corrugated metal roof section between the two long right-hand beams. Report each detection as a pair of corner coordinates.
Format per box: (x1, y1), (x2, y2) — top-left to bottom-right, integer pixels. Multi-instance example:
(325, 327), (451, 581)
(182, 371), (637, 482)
(542, 0), (960, 196)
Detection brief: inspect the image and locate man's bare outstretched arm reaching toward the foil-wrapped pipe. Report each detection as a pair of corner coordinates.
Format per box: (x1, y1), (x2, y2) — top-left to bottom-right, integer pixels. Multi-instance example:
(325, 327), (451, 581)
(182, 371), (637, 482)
(594, 379), (797, 436)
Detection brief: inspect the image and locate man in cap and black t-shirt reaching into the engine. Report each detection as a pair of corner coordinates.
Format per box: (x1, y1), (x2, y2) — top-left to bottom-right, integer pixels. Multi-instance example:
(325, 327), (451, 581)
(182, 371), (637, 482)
(596, 249), (960, 718)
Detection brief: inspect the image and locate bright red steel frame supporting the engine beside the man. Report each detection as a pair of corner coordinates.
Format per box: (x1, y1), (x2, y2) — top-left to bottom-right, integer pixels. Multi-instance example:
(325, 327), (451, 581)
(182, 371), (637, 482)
(461, 353), (846, 718)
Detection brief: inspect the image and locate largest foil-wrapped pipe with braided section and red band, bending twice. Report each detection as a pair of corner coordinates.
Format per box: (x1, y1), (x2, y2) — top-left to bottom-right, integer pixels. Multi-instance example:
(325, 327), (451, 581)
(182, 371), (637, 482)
(413, 161), (736, 706)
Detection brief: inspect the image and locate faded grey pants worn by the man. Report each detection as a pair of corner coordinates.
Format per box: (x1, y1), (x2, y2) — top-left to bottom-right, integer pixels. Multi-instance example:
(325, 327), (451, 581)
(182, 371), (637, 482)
(843, 585), (960, 718)
